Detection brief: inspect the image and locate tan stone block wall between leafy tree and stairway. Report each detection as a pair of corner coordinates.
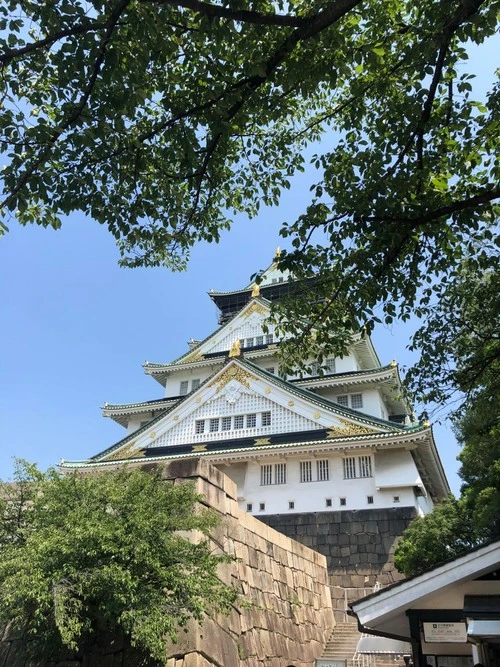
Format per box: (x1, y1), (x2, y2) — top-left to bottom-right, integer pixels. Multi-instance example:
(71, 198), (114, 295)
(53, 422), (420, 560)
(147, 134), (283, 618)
(0, 460), (335, 667)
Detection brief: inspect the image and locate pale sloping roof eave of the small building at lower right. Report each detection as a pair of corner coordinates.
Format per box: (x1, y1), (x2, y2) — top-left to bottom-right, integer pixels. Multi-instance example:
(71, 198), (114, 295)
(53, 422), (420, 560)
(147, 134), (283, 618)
(349, 539), (500, 637)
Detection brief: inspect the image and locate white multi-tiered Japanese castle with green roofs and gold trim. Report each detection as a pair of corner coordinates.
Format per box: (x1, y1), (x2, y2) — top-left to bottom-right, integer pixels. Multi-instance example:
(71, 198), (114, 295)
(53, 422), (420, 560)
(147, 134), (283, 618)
(61, 250), (449, 517)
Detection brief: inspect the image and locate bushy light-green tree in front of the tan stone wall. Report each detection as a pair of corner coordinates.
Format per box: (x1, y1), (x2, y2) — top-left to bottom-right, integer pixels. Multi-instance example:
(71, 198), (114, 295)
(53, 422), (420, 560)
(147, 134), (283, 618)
(0, 462), (236, 661)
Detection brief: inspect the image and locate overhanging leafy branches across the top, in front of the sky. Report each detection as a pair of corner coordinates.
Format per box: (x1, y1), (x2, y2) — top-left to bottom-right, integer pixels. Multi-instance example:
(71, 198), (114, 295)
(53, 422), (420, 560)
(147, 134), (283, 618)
(0, 0), (500, 408)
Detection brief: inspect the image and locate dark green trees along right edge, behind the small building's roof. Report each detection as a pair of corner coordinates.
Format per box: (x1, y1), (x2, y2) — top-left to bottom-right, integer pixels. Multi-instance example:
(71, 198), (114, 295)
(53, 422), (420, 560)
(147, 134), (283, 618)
(395, 266), (500, 575)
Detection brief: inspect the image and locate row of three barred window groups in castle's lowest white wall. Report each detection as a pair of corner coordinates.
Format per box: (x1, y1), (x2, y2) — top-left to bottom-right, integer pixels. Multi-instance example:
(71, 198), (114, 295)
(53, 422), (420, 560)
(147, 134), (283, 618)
(260, 456), (372, 486)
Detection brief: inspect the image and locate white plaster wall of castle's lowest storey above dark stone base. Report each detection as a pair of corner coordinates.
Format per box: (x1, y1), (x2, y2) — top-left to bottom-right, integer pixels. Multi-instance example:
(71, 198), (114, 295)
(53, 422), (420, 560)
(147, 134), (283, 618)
(236, 456), (415, 516)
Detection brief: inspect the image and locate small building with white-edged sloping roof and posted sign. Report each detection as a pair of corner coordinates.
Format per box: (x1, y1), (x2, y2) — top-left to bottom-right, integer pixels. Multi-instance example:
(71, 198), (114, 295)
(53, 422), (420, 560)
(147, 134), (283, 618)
(350, 539), (500, 667)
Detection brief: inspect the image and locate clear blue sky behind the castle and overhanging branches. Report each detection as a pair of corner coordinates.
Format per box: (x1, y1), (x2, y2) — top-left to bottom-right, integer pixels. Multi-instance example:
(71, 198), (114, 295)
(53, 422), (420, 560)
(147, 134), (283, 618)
(0, 40), (498, 492)
